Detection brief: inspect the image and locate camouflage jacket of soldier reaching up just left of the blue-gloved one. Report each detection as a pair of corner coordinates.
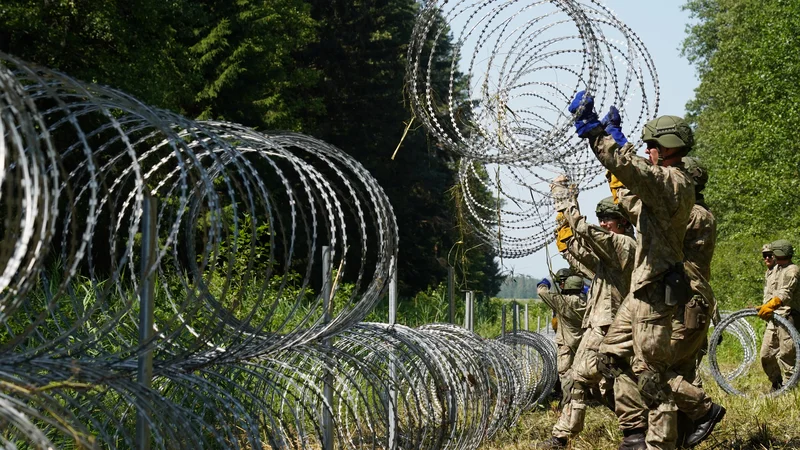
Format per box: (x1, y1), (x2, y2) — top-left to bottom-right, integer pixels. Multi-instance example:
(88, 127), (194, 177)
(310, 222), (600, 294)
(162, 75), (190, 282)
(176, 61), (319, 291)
(553, 186), (636, 328)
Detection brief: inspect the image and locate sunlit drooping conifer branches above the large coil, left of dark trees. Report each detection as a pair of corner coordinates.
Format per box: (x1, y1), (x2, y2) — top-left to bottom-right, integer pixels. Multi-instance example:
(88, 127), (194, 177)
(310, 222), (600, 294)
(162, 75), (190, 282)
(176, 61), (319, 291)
(188, 0), (320, 130)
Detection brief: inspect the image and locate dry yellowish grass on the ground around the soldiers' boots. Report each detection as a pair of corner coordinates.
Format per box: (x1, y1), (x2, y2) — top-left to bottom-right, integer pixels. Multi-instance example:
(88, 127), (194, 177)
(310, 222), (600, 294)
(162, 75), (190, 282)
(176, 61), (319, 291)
(480, 368), (800, 450)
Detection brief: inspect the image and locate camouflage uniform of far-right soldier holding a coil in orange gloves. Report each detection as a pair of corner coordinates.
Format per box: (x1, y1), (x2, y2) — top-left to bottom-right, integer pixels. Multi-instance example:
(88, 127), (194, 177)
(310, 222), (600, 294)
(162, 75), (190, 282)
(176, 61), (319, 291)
(760, 264), (800, 386)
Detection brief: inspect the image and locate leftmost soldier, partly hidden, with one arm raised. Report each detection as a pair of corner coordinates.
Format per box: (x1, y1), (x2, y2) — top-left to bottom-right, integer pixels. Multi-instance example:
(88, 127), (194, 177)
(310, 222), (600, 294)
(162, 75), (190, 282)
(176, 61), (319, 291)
(536, 269), (586, 448)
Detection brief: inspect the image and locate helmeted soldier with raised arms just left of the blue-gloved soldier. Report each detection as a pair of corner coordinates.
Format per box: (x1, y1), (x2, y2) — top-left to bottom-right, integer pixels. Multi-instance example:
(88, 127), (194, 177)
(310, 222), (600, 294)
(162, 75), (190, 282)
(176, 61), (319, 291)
(538, 185), (642, 448)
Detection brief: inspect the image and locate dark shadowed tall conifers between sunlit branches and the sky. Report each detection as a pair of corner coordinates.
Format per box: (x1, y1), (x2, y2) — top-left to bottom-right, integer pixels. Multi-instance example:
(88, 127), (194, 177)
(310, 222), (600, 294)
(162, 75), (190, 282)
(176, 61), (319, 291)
(298, 0), (501, 301)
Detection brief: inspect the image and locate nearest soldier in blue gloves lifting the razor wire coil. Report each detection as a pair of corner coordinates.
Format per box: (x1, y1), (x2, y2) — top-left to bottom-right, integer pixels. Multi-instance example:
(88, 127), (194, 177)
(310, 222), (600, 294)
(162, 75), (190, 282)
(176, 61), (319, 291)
(569, 92), (695, 449)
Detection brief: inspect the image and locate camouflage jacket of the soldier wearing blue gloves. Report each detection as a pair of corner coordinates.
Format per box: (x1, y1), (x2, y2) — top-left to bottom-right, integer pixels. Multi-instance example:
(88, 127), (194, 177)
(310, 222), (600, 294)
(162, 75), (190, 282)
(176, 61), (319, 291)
(592, 136), (695, 292)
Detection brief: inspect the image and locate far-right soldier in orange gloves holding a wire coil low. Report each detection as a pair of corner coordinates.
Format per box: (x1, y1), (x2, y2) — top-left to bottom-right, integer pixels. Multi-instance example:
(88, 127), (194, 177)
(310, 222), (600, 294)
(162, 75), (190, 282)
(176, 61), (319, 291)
(758, 239), (800, 390)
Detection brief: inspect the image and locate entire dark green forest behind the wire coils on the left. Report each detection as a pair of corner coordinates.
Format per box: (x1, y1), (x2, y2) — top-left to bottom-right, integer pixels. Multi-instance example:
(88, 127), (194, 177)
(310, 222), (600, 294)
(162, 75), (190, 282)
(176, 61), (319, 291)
(0, 0), (502, 310)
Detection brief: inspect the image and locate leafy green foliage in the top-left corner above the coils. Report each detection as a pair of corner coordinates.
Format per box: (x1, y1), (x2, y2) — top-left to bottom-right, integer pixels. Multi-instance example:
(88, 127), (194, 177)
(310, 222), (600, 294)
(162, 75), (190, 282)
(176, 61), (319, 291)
(0, 0), (198, 110)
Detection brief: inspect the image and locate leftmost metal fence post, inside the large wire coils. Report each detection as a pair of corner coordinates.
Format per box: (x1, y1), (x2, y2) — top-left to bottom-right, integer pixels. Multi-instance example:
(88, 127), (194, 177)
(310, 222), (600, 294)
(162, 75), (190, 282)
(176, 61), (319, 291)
(136, 194), (158, 450)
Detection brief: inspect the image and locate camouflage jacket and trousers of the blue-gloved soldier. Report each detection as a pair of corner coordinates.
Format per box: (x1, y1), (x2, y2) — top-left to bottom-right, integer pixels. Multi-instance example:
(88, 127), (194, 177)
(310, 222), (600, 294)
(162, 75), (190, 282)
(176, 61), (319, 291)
(592, 136), (695, 449)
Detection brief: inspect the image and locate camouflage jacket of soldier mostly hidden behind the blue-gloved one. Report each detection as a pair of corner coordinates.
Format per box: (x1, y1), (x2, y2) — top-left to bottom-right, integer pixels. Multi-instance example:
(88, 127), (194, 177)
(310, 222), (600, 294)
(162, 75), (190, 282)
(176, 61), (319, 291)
(683, 204), (717, 311)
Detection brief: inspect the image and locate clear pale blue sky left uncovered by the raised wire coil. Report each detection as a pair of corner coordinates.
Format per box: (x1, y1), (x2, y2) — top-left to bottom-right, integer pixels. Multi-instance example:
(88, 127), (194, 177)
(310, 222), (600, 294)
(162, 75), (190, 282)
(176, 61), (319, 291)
(502, 0), (699, 278)
